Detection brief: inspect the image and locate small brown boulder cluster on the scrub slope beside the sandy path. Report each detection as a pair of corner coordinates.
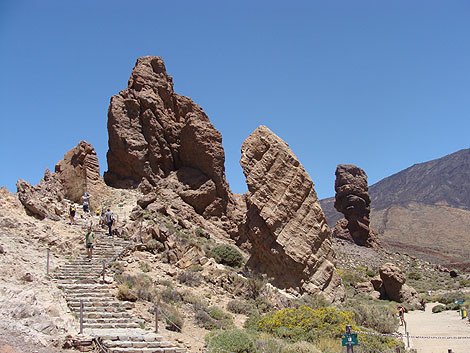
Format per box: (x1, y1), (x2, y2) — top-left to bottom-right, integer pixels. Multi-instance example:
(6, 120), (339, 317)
(355, 263), (419, 307)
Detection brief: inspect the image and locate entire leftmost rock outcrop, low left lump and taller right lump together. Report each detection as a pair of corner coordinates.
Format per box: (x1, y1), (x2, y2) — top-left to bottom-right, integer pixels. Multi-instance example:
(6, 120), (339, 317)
(16, 141), (106, 219)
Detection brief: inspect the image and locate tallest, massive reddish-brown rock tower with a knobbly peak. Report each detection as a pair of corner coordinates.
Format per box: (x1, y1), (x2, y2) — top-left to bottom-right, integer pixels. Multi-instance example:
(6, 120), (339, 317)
(105, 56), (230, 217)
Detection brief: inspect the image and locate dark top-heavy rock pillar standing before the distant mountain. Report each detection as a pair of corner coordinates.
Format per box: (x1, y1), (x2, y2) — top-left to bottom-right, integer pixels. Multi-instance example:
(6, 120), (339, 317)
(332, 164), (379, 247)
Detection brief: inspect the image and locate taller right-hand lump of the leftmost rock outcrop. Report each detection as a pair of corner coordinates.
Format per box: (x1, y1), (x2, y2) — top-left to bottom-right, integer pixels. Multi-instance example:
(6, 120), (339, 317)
(55, 141), (105, 203)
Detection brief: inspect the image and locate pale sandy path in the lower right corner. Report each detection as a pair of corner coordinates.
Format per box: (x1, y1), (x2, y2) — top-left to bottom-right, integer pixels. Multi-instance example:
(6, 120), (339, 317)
(400, 303), (470, 353)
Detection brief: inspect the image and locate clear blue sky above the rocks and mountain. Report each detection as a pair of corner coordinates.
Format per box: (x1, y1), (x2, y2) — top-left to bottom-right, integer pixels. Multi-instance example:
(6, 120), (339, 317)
(0, 0), (470, 198)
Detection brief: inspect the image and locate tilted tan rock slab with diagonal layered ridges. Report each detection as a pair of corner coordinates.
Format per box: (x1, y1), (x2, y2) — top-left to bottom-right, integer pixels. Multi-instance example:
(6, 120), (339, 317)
(240, 126), (345, 301)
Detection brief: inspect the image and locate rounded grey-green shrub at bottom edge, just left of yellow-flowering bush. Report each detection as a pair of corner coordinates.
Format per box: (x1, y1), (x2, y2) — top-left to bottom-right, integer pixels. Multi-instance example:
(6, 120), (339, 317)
(206, 329), (256, 353)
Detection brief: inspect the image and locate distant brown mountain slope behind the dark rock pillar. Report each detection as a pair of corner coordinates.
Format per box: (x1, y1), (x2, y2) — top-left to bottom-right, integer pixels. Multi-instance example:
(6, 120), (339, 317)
(320, 149), (470, 263)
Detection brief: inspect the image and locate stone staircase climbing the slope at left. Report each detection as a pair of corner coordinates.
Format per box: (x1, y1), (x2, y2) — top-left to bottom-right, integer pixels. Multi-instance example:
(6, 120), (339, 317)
(55, 232), (186, 353)
